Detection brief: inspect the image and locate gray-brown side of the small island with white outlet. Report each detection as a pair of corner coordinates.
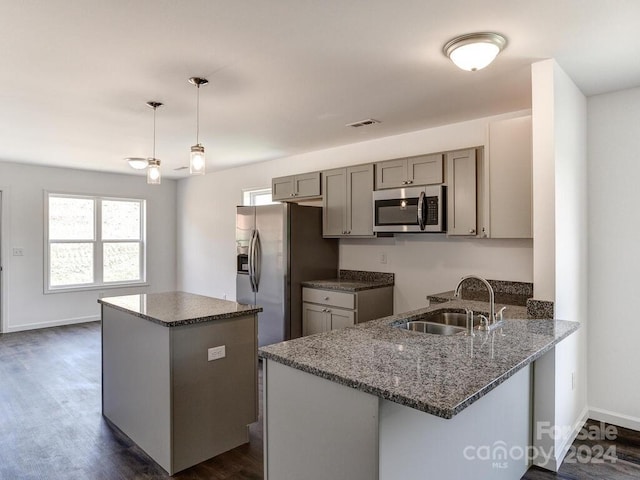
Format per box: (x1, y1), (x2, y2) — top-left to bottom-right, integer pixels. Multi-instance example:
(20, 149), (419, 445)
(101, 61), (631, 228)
(170, 315), (258, 472)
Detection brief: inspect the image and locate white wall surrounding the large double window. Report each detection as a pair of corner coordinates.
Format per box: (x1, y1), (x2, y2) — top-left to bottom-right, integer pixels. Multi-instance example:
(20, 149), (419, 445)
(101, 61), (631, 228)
(0, 162), (176, 332)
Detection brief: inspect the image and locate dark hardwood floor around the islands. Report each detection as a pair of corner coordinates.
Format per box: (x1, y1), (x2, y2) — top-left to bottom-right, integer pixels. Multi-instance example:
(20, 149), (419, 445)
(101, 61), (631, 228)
(0, 322), (640, 480)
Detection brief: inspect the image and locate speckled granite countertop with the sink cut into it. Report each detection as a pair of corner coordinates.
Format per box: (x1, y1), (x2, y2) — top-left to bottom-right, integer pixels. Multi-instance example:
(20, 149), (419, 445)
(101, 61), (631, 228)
(259, 300), (580, 418)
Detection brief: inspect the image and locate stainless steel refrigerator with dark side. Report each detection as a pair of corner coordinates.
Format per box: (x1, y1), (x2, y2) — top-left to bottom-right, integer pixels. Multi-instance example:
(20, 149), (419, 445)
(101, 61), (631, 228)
(236, 203), (338, 346)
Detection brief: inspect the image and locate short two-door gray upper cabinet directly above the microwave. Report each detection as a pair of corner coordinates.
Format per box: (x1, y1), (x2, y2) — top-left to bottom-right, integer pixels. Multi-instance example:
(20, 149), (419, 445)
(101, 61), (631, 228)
(375, 153), (443, 190)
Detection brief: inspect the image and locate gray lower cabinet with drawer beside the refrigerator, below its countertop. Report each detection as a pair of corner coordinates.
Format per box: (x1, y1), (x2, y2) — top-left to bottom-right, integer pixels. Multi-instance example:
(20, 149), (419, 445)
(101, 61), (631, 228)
(302, 287), (393, 336)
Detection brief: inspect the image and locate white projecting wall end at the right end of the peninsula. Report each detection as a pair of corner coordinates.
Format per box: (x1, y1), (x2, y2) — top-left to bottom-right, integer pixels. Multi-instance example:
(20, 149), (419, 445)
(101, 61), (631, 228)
(532, 60), (588, 469)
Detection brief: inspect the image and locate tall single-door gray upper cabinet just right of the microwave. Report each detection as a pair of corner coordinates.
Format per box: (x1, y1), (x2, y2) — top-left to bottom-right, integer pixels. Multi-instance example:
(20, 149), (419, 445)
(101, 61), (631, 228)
(446, 148), (478, 236)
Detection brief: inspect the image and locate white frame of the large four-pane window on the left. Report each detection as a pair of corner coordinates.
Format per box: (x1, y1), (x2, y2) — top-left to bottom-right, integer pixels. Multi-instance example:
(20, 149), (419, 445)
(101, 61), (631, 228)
(43, 190), (148, 294)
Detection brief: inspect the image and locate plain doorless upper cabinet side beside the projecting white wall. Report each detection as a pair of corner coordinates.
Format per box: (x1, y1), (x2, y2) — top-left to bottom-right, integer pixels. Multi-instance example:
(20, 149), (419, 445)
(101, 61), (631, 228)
(481, 116), (533, 238)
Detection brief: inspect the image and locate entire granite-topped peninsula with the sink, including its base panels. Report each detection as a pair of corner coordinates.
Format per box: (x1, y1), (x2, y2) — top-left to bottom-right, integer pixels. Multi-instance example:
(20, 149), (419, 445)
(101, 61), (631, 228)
(260, 300), (579, 480)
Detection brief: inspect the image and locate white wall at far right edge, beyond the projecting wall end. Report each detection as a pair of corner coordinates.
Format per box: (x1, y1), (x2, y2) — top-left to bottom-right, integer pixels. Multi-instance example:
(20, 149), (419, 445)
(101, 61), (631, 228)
(588, 84), (640, 430)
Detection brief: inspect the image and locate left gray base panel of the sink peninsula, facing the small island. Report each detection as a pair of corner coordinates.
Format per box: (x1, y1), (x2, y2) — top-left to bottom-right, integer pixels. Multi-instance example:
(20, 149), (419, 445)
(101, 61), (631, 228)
(263, 359), (380, 480)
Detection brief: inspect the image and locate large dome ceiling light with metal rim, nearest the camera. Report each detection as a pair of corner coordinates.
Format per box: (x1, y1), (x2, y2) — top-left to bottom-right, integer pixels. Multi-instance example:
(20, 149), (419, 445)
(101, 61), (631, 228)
(442, 32), (507, 72)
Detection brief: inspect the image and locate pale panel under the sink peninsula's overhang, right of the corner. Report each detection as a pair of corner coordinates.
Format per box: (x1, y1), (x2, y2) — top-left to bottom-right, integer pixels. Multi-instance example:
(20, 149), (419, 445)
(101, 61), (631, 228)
(380, 365), (532, 480)
